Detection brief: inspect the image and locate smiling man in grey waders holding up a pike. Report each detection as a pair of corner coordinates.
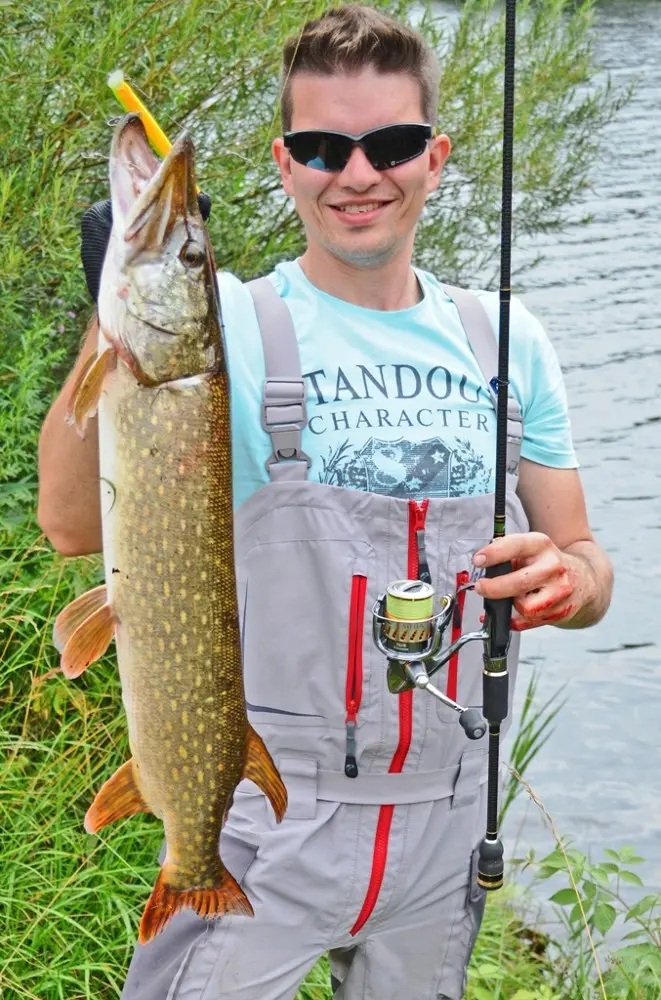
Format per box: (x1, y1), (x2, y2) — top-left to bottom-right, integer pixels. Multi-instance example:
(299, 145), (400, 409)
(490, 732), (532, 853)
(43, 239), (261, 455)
(39, 4), (612, 1000)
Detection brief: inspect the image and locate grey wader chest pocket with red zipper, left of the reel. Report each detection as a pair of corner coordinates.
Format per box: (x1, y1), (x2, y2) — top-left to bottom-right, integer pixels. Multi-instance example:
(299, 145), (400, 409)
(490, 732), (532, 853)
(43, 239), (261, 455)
(240, 538), (374, 730)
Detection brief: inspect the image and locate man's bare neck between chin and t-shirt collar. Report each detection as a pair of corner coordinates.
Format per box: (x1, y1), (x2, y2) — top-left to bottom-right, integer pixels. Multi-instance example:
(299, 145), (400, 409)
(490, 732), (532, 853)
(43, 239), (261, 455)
(299, 247), (422, 311)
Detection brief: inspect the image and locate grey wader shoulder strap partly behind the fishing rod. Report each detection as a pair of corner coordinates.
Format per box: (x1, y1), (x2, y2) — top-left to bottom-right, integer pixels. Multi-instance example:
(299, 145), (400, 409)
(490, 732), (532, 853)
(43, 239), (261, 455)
(441, 285), (523, 479)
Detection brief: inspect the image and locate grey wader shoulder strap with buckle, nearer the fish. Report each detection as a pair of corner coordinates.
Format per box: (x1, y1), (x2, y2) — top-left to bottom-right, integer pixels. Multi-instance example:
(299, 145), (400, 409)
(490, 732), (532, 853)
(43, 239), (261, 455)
(247, 278), (311, 482)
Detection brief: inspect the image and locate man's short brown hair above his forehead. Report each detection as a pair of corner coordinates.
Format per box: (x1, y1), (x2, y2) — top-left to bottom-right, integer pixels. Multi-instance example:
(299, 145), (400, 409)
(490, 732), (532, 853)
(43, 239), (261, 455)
(280, 3), (440, 132)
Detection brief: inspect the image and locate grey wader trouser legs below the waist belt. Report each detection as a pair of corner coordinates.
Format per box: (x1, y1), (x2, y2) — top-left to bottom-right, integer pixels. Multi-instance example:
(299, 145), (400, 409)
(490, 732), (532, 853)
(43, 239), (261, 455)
(122, 786), (483, 1000)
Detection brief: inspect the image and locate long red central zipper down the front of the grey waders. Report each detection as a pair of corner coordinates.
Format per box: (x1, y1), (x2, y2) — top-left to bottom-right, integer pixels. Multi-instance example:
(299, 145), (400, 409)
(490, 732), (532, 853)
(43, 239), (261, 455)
(349, 500), (429, 935)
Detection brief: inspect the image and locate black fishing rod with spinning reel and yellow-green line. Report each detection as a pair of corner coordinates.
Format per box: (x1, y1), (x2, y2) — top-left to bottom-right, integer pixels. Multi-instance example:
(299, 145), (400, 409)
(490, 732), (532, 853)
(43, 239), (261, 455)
(372, 0), (516, 890)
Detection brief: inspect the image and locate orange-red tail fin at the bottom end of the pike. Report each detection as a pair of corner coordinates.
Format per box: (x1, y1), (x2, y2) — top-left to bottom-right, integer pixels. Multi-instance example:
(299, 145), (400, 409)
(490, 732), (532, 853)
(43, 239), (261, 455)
(138, 861), (254, 944)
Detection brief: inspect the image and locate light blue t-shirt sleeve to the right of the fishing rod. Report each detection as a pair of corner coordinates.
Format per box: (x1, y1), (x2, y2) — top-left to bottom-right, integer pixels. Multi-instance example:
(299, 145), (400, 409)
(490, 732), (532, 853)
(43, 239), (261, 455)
(512, 300), (578, 469)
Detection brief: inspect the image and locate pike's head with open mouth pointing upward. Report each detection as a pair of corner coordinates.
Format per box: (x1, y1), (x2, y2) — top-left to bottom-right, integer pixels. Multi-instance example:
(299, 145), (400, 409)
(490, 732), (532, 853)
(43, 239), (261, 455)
(98, 114), (224, 386)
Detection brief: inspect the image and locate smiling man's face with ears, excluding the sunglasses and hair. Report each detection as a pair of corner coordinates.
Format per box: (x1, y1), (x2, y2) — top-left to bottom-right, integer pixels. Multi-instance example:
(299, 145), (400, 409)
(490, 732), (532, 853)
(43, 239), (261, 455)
(273, 67), (450, 267)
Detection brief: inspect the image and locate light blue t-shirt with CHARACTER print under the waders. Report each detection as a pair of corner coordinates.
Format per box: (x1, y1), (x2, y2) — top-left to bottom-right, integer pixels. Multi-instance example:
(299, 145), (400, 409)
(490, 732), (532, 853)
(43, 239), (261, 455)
(218, 261), (578, 507)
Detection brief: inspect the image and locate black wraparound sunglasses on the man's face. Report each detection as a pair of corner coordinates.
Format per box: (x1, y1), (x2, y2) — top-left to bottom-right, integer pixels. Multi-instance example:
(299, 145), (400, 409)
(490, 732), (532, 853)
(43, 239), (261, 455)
(284, 123), (434, 172)
